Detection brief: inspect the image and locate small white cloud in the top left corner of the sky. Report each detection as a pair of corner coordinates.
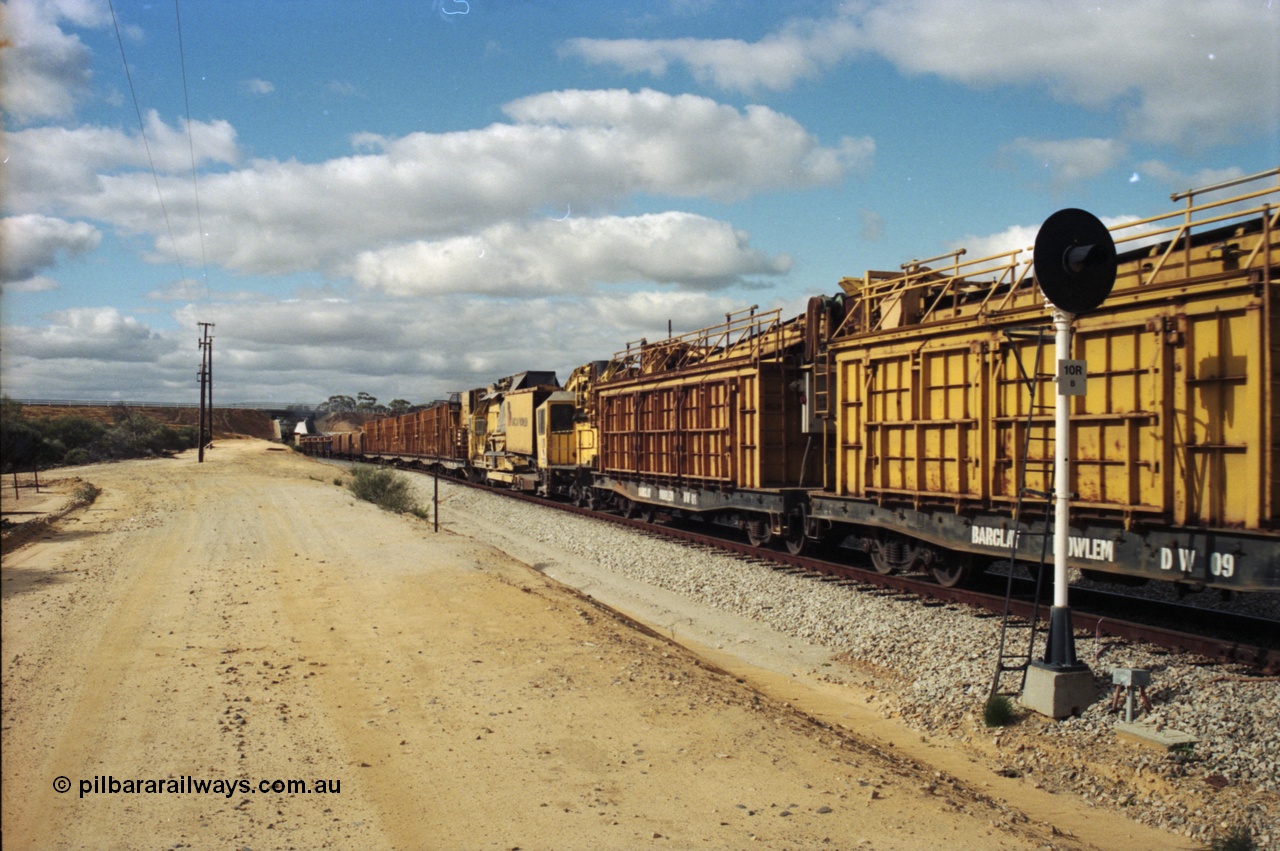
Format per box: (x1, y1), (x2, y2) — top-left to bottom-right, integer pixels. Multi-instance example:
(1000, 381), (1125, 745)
(0, 0), (110, 123)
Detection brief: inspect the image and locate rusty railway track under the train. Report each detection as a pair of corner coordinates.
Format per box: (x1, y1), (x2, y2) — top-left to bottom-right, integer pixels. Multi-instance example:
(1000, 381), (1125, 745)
(414, 468), (1280, 676)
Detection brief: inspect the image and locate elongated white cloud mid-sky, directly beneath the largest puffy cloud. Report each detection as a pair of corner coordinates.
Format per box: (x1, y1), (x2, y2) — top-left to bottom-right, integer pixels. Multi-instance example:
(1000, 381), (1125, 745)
(352, 212), (791, 296)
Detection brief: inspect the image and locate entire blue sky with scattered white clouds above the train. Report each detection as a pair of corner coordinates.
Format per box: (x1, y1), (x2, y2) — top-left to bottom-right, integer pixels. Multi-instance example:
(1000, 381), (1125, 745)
(0, 0), (1280, 402)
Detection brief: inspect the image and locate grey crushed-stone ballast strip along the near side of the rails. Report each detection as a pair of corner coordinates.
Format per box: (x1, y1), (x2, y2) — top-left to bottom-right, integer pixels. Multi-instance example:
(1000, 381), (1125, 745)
(415, 477), (1280, 848)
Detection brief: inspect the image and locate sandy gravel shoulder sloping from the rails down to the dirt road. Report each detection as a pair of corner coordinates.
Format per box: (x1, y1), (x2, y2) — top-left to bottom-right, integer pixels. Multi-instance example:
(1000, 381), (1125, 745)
(407, 465), (1280, 848)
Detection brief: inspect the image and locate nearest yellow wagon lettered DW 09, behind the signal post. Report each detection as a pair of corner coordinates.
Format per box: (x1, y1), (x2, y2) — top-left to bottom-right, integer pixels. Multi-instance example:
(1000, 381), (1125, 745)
(810, 173), (1280, 589)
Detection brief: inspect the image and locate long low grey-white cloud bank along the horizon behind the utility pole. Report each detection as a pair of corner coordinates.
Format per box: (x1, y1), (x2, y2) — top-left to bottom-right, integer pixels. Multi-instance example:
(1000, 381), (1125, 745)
(0, 290), (773, 403)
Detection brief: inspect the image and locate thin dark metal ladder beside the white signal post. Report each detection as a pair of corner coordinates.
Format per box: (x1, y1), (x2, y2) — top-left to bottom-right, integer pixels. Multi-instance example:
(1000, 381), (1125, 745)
(988, 328), (1055, 699)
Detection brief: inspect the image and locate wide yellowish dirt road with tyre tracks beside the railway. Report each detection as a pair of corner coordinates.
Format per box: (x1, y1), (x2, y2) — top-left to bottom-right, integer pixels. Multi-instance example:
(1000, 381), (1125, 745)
(0, 440), (1172, 851)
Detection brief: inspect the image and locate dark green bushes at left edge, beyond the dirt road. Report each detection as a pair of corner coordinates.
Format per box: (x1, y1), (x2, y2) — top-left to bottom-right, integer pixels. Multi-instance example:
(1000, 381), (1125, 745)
(0, 397), (200, 472)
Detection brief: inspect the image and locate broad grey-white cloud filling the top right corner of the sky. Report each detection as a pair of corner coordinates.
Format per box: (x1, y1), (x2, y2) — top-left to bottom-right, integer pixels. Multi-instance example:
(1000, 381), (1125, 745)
(863, 0), (1280, 145)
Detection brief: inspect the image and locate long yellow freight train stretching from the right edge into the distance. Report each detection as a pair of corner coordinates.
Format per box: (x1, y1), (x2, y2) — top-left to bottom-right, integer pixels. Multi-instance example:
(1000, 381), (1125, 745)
(302, 169), (1280, 591)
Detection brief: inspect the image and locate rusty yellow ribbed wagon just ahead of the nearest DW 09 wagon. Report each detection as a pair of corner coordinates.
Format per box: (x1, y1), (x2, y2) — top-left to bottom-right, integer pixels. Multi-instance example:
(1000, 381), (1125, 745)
(595, 308), (817, 540)
